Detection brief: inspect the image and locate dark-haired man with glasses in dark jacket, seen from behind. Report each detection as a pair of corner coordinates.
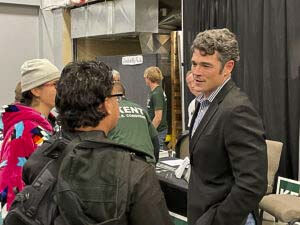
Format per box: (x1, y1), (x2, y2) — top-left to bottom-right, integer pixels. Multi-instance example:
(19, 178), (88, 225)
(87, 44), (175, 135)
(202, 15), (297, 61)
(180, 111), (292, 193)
(12, 61), (173, 225)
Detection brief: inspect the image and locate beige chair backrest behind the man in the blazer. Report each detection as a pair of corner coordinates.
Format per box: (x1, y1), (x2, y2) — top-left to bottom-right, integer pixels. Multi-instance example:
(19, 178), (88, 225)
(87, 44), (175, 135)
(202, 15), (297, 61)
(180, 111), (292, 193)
(266, 140), (283, 194)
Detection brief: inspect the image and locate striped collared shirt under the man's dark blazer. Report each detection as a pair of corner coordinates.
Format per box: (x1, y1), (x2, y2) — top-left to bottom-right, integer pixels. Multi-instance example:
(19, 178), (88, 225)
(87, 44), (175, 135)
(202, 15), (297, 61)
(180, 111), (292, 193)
(192, 77), (230, 136)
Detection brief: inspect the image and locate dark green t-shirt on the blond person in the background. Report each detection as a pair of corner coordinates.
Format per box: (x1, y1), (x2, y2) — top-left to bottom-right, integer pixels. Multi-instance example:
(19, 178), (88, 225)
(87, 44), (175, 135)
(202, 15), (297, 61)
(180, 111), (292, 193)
(147, 86), (168, 132)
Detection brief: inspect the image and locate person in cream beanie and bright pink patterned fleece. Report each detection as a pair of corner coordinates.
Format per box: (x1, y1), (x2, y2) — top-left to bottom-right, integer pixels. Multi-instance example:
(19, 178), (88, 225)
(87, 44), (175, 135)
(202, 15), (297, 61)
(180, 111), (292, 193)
(0, 59), (60, 210)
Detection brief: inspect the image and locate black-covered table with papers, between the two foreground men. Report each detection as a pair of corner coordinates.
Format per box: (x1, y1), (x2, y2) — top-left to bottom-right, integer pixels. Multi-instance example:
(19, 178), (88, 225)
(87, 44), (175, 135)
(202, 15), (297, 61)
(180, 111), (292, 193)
(156, 158), (188, 217)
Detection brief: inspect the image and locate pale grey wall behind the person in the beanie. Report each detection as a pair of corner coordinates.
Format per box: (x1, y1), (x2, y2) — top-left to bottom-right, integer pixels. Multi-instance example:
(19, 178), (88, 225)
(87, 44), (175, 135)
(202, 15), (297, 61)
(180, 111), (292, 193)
(0, 1), (63, 106)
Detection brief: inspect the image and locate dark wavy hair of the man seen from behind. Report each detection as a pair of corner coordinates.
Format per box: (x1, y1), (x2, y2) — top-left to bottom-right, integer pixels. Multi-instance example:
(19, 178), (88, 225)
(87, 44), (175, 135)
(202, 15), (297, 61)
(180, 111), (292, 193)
(55, 61), (113, 131)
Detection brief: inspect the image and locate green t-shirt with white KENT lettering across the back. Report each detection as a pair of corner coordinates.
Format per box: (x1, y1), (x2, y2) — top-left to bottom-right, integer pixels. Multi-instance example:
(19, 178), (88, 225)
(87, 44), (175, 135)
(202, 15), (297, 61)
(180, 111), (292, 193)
(108, 99), (157, 162)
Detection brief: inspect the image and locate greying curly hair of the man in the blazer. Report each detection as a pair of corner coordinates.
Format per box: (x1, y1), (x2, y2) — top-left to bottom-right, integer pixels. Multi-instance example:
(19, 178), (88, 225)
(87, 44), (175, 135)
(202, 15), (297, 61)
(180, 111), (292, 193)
(191, 28), (240, 67)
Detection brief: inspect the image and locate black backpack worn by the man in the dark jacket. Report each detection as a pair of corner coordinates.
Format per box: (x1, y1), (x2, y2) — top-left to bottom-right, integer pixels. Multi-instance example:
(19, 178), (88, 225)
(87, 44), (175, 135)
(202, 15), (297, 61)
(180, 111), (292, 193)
(3, 137), (80, 225)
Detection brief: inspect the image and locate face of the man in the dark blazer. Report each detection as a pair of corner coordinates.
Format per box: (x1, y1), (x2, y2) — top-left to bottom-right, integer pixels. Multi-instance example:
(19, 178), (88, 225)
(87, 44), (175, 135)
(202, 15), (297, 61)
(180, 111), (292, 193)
(191, 49), (234, 97)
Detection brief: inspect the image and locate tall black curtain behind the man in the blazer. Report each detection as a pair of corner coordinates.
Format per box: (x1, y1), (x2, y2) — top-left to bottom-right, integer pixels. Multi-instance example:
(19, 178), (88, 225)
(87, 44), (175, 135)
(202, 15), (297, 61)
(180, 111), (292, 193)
(183, 0), (300, 179)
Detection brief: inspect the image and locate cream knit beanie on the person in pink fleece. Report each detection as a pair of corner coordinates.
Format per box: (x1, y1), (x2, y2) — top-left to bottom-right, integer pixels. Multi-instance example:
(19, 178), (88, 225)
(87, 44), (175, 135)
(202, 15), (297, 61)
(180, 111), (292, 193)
(21, 59), (60, 92)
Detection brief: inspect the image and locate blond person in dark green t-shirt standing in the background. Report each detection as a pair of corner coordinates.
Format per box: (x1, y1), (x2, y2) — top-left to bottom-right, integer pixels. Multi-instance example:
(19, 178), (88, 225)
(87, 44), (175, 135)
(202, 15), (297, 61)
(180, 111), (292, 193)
(144, 66), (168, 149)
